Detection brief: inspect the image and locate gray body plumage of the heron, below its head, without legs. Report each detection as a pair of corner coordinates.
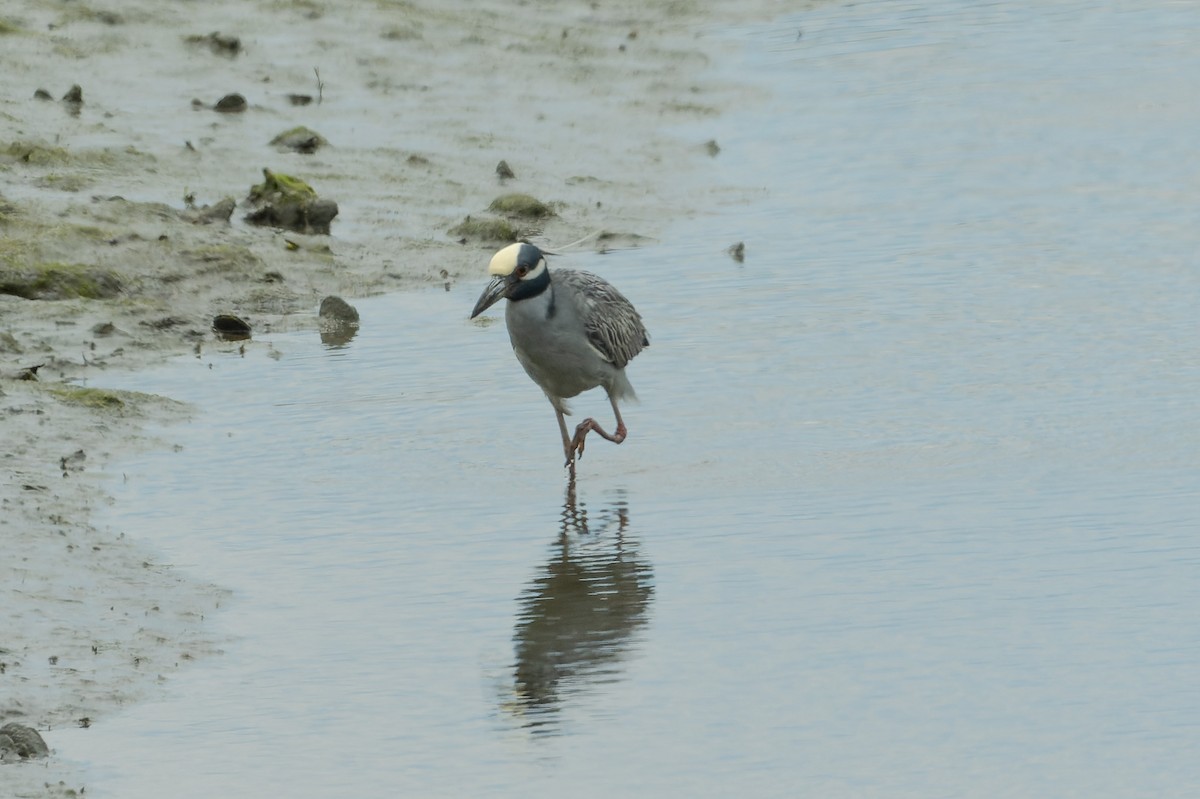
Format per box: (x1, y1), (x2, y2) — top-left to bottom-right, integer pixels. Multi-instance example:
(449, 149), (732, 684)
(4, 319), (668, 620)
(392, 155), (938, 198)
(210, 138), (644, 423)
(504, 270), (649, 414)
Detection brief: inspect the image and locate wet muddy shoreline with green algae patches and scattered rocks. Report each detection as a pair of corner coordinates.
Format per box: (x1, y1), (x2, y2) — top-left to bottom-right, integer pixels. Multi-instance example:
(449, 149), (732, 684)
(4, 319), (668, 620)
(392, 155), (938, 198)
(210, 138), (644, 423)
(0, 0), (770, 797)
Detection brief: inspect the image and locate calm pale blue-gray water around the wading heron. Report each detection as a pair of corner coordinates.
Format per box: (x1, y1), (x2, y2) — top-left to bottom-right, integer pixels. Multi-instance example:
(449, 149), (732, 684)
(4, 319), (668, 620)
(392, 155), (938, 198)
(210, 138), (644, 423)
(70, 1), (1200, 798)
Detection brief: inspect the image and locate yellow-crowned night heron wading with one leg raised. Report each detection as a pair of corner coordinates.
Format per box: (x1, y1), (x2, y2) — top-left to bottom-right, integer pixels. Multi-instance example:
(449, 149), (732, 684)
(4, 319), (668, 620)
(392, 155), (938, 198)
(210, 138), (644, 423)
(470, 244), (650, 476)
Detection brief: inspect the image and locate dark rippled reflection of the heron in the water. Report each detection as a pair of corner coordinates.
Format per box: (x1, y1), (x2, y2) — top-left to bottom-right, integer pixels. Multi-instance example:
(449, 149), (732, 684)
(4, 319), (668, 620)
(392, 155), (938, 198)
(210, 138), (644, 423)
(505, 482), (654, 733)
